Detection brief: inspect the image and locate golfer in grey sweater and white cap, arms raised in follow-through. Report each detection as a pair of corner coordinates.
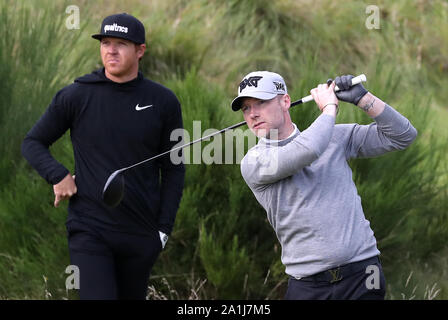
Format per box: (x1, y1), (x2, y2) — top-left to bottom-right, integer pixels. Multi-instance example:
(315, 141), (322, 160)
(232, 71), (417, 299)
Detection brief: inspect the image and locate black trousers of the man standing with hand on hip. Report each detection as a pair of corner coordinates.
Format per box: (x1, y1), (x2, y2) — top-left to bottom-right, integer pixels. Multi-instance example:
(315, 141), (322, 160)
(66, 221), (162, 300)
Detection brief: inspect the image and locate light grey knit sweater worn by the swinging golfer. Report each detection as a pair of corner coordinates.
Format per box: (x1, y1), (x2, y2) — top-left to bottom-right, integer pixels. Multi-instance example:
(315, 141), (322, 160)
(241, 104), (417, 278)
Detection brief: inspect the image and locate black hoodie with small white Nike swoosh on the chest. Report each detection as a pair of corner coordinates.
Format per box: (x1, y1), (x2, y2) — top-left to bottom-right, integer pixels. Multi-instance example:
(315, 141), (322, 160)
(22, 68), (185, 234)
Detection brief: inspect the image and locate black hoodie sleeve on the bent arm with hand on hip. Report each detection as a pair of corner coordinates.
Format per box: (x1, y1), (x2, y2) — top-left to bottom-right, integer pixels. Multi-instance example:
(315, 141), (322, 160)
(22, 90), (71, 185)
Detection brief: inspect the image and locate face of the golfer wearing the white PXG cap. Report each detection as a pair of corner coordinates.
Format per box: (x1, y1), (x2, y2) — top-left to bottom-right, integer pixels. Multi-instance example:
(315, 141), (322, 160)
(241, 95), (290, 140)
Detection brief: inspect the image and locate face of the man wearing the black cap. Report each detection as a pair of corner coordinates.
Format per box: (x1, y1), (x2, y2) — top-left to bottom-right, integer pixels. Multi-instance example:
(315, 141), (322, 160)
(101, 37), (146, 77)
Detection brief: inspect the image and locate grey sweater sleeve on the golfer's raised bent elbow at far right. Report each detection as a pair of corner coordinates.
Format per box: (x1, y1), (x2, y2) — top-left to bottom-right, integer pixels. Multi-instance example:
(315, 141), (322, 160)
(347, 104), (417, 158)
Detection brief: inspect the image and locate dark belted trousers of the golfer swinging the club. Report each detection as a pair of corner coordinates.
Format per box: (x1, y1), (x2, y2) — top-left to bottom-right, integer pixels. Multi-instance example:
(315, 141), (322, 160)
(285, 257), (386, 300)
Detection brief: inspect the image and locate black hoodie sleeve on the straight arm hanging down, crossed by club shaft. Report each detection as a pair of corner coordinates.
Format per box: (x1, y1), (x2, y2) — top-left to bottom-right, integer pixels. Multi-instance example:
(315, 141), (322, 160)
(158, 99), (185, 234)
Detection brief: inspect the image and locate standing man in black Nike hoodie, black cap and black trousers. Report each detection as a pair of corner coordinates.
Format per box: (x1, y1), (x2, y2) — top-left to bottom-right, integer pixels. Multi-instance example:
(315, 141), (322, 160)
(22, 13), (185, 299)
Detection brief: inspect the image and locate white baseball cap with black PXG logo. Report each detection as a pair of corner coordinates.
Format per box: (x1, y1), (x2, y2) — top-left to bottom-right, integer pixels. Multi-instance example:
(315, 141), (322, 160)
(232, 71), (288, 111)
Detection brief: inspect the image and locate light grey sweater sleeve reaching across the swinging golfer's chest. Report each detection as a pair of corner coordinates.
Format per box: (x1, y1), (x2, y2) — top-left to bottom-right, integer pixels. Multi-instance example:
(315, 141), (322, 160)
(241, 114), (335, 187)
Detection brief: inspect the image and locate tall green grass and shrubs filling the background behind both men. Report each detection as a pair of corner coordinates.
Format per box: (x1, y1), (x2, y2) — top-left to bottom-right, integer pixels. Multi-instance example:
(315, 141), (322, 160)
(0, 0), (448, 299)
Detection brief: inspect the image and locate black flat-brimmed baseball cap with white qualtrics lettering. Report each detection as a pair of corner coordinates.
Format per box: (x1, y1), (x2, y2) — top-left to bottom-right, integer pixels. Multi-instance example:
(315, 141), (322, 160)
(92, 13), (145, 44)
